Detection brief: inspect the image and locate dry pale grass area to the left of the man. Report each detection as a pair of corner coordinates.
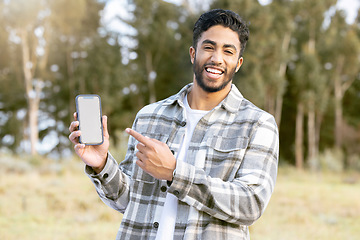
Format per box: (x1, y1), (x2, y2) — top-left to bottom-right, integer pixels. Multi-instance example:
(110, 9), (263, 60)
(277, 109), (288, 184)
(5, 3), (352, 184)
(0, 160), (122, 240)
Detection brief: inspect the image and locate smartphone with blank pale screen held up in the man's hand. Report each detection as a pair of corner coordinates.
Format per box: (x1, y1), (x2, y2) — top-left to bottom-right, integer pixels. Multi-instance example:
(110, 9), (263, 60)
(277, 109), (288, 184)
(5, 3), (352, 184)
(75, 94), (104, 145)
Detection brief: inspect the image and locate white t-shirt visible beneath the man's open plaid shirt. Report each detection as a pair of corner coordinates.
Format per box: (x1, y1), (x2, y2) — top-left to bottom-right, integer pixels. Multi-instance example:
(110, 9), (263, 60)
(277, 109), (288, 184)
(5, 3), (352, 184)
(156, 95), (209, 240)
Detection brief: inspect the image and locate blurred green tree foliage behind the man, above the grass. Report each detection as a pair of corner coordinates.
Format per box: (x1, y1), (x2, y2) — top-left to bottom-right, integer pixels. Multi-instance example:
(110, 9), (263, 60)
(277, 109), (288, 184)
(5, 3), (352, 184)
(0, 0), (360, 169)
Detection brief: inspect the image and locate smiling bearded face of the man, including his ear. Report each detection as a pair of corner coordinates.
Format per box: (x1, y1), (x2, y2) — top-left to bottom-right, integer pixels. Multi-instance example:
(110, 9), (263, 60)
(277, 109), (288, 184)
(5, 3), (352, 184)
(190, 25), (243, 92)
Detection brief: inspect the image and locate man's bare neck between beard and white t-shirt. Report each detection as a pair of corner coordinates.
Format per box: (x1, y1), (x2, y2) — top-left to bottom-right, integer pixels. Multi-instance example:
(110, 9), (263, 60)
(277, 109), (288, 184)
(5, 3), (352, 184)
(187, 80), (231, 111)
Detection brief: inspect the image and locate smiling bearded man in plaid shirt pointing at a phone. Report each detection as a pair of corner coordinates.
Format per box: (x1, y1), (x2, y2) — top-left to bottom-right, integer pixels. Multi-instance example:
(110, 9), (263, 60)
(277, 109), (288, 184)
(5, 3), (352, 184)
(69, 9), (278, 240)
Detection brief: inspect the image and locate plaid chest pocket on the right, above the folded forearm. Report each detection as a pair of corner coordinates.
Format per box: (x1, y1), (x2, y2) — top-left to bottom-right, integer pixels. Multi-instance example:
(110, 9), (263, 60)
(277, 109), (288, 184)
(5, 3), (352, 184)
(205, 136), (249, 180)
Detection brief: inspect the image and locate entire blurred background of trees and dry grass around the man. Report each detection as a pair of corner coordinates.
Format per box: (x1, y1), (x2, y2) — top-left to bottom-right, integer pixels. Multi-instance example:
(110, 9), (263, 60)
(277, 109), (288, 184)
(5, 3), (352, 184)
(0, 0), (360, 240)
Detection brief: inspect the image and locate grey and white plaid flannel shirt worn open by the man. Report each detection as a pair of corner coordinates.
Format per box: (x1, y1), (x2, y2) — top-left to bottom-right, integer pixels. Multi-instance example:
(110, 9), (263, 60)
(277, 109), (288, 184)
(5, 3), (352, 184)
(86, 84), (279, 240)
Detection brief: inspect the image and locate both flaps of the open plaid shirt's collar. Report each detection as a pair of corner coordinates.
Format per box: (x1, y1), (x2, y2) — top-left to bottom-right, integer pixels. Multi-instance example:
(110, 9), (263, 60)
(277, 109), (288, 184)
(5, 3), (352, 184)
(163, 83), (244, 113)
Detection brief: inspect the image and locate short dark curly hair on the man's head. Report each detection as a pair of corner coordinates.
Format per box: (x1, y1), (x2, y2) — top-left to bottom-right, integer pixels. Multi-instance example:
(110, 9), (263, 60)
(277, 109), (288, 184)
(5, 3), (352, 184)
(193, 9), (250, 57)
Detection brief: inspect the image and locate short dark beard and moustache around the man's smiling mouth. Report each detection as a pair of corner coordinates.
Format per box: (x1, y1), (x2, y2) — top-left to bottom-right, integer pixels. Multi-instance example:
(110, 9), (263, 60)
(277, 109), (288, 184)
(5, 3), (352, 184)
(193, 56), (236, 93)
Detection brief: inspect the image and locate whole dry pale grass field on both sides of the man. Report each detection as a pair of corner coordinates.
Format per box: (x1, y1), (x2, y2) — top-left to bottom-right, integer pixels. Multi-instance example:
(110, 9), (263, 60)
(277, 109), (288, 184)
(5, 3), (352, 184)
(0, 156), (360, 240)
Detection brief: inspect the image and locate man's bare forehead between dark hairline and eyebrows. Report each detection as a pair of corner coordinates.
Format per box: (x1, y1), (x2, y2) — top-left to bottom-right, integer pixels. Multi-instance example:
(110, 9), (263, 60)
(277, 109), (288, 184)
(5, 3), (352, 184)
(197, 25), (240, 51)
